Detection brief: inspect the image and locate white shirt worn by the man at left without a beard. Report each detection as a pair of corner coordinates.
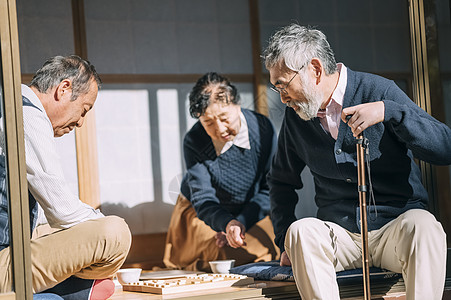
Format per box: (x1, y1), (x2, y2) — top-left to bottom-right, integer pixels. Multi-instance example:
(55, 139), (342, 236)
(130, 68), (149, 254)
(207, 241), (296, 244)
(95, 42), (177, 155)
(22, 85), (103, 228)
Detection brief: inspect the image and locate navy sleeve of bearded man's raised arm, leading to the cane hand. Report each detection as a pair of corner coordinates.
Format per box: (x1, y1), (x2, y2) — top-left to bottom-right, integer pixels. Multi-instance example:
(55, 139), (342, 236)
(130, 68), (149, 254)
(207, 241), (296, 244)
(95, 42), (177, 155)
(384, 82), (451, 165)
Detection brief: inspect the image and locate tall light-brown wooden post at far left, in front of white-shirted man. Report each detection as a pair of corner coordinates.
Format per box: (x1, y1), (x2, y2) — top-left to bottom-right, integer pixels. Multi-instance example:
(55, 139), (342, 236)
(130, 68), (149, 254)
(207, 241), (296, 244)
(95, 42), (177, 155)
(0, 0), (33, 299)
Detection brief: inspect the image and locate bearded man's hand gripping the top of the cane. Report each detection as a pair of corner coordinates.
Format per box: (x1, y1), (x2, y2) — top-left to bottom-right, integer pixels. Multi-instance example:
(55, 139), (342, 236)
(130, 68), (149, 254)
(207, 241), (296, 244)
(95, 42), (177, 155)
(341, 101), (385, 137)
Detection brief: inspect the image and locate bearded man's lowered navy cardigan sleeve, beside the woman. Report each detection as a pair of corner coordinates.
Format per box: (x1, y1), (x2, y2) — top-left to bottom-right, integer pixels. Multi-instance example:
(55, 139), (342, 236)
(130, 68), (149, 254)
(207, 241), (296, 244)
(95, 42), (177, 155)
(268, 108), (305, 252)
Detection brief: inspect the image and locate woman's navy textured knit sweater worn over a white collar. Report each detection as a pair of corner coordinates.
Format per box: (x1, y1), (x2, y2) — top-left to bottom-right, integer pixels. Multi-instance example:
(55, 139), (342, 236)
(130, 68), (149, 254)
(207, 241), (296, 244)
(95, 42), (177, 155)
(181, 109), (276, 231)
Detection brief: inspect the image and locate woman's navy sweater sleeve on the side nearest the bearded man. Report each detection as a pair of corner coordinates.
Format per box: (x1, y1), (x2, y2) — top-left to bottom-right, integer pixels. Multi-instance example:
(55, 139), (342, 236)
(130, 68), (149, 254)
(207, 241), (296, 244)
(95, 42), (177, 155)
(236, 120), (277, 230)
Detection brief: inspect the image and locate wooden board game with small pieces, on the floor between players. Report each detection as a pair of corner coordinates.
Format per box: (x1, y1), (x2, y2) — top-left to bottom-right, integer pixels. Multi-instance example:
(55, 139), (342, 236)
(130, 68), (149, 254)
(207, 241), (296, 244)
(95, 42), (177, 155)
(122, 274), (254, 295)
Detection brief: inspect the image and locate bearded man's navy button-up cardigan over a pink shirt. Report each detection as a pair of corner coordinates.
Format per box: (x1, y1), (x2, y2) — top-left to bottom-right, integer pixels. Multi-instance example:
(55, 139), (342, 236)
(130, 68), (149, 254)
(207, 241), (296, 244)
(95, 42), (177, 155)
(268, 69), (451, 251)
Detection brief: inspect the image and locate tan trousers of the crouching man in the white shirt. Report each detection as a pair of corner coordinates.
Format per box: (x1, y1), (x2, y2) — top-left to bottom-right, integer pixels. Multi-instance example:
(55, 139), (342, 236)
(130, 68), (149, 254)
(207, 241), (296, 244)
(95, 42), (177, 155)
(0, 216), (131, 293)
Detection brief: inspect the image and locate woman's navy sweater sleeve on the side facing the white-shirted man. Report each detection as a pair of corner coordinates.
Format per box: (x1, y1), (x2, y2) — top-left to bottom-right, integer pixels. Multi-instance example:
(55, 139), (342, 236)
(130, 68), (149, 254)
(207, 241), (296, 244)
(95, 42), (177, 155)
(183, 133), (234, 231)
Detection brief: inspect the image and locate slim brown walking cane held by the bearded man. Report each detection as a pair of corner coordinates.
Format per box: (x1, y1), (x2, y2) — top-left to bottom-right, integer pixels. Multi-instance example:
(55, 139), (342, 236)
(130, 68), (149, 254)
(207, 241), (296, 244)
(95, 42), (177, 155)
(346, 115), (371, 300)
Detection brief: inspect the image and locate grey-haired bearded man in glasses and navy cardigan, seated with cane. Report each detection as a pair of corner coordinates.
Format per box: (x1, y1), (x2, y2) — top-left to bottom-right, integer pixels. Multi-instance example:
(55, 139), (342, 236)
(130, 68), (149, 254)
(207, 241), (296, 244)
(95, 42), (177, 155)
(263, 24), (451, 300)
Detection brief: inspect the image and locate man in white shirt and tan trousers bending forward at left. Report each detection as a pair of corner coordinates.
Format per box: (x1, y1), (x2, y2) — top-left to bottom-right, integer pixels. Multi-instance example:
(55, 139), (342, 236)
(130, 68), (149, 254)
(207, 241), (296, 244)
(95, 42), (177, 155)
(0, 56), (131, 299)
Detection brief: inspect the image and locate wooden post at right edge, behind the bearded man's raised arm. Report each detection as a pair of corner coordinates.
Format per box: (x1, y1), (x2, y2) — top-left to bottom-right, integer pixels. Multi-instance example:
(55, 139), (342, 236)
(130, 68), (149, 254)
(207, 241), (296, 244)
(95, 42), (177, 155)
(409, 0), (451, 244)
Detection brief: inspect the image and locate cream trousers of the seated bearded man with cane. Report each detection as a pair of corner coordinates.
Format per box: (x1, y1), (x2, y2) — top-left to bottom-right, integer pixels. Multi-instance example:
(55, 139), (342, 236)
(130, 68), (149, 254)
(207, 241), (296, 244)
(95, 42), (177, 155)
(285, 209), (446, 300)
